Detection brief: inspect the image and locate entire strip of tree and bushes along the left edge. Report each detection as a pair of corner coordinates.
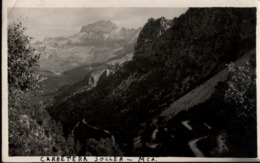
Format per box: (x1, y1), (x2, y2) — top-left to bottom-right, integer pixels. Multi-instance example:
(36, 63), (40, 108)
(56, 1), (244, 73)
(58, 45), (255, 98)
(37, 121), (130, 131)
(8, 23), (73, 156)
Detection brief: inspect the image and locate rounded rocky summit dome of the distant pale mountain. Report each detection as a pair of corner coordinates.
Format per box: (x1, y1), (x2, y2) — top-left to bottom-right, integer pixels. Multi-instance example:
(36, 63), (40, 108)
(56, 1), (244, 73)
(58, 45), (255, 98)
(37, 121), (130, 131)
(80, 20), (117, 32)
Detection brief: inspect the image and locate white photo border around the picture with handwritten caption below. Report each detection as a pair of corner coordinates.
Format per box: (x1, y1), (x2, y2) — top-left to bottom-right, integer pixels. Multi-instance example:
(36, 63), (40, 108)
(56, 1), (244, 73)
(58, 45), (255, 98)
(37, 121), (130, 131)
(2, 0), (260, 162)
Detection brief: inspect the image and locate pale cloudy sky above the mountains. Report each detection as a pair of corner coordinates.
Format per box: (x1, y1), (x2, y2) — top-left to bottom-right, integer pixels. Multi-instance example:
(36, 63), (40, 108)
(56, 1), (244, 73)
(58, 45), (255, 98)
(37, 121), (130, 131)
(7, 8), (187, 41)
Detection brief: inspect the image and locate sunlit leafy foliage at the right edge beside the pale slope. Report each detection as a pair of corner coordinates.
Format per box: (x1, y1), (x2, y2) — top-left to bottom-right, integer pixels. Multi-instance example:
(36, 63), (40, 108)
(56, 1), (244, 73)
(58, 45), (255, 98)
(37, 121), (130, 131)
(225, 62), (256, 119)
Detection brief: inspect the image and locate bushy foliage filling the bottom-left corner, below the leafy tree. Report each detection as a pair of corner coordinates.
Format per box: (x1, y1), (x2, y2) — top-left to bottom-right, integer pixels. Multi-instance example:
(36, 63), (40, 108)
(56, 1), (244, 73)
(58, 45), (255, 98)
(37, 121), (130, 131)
(9, 101), (75, 156)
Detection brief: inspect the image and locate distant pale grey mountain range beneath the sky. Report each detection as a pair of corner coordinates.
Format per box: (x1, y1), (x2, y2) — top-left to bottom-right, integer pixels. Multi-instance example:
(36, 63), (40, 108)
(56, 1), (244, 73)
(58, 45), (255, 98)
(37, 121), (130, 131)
(35, 21), (140, 74)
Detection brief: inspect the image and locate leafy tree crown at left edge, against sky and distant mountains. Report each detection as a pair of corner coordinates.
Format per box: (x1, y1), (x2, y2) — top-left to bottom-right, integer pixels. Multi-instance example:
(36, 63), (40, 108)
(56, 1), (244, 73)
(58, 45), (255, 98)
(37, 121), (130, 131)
(8, 22), (44, 100)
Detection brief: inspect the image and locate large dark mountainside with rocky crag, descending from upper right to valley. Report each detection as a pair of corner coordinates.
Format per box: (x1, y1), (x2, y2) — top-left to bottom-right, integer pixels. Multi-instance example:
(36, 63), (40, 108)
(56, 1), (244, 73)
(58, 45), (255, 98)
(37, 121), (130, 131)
(49, 8), (256, 155)
